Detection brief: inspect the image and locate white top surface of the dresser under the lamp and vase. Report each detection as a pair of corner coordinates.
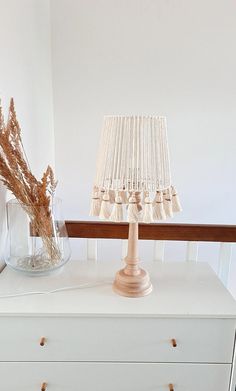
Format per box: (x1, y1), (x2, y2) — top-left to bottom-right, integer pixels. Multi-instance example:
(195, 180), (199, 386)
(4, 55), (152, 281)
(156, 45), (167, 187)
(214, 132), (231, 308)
(0, 261), (236, 319)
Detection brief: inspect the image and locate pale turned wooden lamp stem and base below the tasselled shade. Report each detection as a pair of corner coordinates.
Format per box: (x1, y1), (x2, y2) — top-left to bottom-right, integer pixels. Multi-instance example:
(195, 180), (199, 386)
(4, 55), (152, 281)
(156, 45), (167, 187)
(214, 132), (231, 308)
(113, 223), (152, 297)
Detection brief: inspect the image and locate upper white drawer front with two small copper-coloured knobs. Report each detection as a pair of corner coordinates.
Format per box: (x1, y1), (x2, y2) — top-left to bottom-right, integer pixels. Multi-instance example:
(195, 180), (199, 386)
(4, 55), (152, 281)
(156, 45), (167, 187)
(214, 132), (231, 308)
(0, 317), (235, 363)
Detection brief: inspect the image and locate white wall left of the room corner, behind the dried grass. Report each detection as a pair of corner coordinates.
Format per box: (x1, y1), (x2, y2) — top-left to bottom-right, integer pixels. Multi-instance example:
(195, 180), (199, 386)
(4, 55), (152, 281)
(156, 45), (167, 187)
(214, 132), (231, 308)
(0, 0), (54, 268)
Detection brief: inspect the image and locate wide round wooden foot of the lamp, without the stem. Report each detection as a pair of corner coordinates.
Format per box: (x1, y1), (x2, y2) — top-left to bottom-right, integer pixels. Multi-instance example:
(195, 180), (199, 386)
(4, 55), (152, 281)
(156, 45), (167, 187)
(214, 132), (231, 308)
(113, 268), (152, 297)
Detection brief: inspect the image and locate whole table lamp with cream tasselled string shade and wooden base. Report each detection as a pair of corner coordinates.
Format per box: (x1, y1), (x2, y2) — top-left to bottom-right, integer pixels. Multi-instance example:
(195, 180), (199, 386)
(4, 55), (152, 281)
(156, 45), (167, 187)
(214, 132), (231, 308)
(90, 115), (181, 297)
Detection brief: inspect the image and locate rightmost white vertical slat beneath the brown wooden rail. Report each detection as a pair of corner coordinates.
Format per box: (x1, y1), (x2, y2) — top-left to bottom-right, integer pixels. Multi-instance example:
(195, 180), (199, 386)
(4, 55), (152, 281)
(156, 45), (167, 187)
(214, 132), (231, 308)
(218, 243), (232, 287)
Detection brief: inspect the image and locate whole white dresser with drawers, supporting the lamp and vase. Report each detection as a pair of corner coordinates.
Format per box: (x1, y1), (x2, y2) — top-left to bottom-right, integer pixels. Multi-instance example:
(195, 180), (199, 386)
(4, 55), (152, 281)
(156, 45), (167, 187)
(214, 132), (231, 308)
(0, 261), (236, 391)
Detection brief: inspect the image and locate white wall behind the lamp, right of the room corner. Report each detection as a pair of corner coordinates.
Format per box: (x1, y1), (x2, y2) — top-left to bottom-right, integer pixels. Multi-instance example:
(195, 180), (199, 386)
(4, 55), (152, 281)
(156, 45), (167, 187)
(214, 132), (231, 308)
(51, 0), (236, 224)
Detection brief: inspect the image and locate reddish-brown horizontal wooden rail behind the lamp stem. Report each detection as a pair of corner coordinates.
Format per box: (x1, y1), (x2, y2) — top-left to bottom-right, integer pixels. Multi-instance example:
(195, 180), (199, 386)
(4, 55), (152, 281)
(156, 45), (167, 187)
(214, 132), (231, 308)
(66, 221), (236, 242)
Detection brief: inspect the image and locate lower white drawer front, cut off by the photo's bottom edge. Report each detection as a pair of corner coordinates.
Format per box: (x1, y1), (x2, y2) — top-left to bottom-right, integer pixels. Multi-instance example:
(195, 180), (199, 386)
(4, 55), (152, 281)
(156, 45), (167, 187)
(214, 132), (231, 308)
(0, 362), (230, 391)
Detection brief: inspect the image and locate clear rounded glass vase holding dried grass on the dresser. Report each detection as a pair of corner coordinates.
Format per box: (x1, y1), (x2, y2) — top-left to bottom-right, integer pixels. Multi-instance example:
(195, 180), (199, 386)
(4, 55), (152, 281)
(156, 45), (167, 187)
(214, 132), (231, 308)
(5, 198), (71, 276)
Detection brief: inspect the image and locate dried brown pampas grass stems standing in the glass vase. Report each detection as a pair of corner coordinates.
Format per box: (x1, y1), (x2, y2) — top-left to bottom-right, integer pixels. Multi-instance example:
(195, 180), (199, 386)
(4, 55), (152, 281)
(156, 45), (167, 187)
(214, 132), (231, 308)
(0, 99), (60, 263)
